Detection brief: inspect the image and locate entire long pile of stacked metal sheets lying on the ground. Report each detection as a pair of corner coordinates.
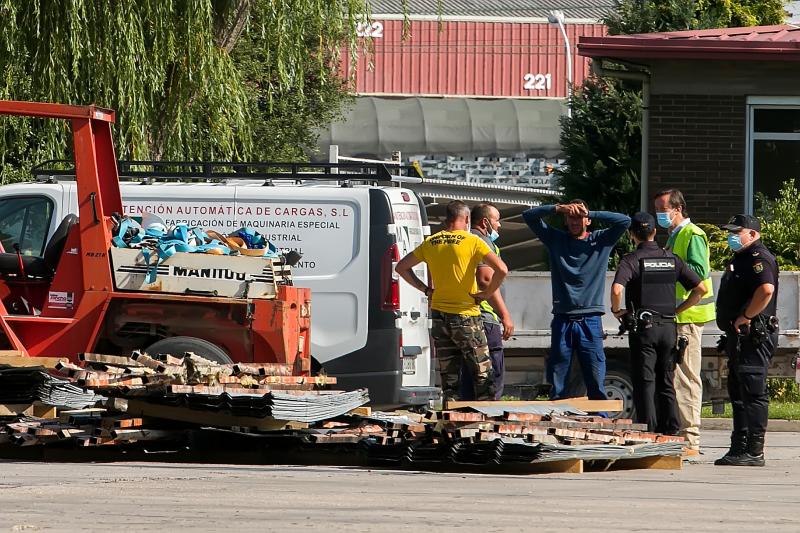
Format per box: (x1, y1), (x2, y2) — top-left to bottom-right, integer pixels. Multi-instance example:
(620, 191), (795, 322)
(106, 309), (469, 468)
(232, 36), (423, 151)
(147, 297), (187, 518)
(0, 352), (684, 473)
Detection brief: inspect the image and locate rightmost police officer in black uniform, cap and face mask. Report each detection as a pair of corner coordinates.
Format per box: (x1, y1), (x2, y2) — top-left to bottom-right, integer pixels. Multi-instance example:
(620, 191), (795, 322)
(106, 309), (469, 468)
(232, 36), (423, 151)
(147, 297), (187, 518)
(714, 215), (778, 466)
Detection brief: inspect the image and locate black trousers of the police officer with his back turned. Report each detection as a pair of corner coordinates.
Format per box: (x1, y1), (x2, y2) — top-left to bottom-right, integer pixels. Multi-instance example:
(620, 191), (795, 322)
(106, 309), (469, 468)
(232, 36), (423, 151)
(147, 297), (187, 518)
(628, 321), (679, 435)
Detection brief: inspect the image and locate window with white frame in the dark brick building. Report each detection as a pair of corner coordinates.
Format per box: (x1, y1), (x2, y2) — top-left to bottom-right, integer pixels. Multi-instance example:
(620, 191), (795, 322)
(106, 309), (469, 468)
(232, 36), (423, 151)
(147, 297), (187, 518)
(745, 96), (800, 213)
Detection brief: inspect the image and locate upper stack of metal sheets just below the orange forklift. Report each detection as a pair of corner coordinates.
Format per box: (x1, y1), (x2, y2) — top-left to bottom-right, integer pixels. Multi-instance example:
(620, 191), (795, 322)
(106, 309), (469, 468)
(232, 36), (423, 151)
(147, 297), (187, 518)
(61, 352), (369, 425)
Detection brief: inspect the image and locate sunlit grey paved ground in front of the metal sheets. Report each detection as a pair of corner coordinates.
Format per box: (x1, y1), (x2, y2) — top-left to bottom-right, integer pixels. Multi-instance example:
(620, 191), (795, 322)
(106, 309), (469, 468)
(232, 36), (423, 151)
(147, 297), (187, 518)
(0, 431), (800, 533)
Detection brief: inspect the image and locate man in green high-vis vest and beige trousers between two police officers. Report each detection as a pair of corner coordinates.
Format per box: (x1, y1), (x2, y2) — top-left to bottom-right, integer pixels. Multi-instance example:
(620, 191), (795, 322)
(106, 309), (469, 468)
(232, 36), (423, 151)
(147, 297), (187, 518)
(654, 189), (716, 455)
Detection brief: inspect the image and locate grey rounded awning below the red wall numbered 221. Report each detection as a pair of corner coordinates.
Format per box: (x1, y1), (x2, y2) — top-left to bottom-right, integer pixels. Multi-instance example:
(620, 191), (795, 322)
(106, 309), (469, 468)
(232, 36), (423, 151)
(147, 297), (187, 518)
(319, 96), (564, 158)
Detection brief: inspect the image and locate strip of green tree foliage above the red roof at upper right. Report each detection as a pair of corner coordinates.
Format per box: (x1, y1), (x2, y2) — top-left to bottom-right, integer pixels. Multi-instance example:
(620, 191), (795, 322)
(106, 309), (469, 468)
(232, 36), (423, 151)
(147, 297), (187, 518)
(603, 0), (785, 35)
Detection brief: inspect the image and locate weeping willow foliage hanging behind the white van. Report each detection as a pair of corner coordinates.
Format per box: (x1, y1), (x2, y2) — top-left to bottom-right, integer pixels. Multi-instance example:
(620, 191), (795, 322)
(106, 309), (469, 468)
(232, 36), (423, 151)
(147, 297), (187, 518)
(0, 0), (368, 181)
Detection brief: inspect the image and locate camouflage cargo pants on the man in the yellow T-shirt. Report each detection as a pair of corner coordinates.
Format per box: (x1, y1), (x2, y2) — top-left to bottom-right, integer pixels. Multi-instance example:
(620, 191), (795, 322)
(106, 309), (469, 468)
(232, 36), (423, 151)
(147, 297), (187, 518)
(431, 311), (494, 400)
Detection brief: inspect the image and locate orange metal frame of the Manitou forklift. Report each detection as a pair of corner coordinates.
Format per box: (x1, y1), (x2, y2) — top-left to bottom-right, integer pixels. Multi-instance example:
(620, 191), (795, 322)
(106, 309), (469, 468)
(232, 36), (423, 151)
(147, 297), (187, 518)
(0, 101), (310, 372)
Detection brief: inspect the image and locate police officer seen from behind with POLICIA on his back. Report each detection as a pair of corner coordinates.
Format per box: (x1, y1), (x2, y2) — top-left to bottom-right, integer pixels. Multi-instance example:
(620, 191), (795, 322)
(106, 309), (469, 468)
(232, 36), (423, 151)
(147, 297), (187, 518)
(611, 213), (707, 435)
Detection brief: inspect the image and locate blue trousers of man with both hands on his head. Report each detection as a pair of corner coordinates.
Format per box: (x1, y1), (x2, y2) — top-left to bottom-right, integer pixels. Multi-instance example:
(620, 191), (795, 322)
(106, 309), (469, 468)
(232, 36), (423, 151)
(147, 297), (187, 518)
(546, 315), (608, 400)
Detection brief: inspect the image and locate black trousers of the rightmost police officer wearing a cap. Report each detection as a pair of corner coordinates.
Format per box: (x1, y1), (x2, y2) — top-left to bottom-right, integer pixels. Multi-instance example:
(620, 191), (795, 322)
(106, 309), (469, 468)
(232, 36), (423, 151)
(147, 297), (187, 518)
(725, 331), (778, 437)
